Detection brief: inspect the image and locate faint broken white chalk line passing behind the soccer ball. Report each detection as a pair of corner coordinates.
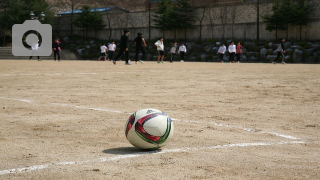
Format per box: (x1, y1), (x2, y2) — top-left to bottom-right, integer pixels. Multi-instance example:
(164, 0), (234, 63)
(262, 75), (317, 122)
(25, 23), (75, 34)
(0, 97), (301, 140)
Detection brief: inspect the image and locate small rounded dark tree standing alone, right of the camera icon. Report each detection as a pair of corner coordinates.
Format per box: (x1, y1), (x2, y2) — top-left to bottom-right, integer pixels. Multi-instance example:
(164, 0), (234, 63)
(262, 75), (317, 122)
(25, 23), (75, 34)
(74, 6), (105, 37)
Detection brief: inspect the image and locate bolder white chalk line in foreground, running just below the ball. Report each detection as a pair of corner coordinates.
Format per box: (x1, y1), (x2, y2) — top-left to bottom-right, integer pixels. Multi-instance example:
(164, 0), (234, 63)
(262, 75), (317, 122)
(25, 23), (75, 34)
(0, 141), (306, 175)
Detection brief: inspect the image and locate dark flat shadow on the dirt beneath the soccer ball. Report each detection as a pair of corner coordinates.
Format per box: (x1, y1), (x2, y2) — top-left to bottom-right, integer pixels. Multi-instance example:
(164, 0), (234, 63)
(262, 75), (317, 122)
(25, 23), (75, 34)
(102, 147), (162, 155)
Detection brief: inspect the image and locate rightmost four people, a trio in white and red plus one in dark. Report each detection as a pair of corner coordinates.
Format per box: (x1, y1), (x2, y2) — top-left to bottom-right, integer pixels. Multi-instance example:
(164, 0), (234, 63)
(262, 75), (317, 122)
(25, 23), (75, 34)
(217, 38), (286, 64)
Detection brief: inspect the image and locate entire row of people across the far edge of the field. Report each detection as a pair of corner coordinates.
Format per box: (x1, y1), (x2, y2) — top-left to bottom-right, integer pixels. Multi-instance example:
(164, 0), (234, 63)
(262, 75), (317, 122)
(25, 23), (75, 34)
(29, 30), (286, 65)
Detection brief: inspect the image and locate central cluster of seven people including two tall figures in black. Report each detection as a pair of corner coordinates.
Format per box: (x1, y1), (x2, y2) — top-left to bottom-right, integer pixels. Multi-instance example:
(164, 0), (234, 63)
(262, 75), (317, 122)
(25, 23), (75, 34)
(98, 30), (187, 65)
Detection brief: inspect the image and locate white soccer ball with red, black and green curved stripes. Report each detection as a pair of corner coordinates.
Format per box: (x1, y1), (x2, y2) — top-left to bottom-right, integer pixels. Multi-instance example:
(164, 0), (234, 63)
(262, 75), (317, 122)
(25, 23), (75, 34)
(125, 109), (174, 150)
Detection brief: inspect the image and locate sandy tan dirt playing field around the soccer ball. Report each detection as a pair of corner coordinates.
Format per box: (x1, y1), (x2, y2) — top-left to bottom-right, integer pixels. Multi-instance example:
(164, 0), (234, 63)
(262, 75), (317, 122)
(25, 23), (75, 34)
(0, 60), (320, 180)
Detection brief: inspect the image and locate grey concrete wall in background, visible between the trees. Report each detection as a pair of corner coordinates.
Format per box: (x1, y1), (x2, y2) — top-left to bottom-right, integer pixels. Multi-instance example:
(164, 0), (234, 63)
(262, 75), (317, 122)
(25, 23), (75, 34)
(60, 3), (320, 41)
